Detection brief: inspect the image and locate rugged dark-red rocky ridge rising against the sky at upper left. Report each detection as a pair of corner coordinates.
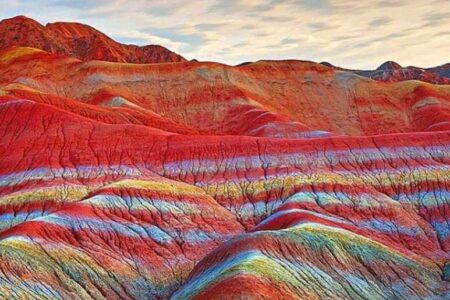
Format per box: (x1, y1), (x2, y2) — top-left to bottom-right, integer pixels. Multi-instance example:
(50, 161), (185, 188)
(0, 16), (185, 63)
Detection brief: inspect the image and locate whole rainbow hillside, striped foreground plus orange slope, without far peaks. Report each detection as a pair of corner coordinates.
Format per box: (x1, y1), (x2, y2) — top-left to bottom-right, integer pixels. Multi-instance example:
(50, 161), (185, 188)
(0, 15), (450, 299)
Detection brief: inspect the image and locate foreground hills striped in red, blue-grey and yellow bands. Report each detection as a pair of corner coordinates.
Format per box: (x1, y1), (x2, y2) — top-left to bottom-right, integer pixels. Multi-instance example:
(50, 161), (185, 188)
(0, 84), (450, 299)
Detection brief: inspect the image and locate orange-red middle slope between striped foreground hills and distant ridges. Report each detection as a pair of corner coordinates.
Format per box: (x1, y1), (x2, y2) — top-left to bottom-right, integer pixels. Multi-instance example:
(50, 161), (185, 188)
(0, 48), (450, 138)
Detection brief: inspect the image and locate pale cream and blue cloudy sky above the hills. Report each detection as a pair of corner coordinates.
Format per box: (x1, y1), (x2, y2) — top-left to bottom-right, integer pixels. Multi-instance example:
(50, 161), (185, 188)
(0, 0), (450, 69)
